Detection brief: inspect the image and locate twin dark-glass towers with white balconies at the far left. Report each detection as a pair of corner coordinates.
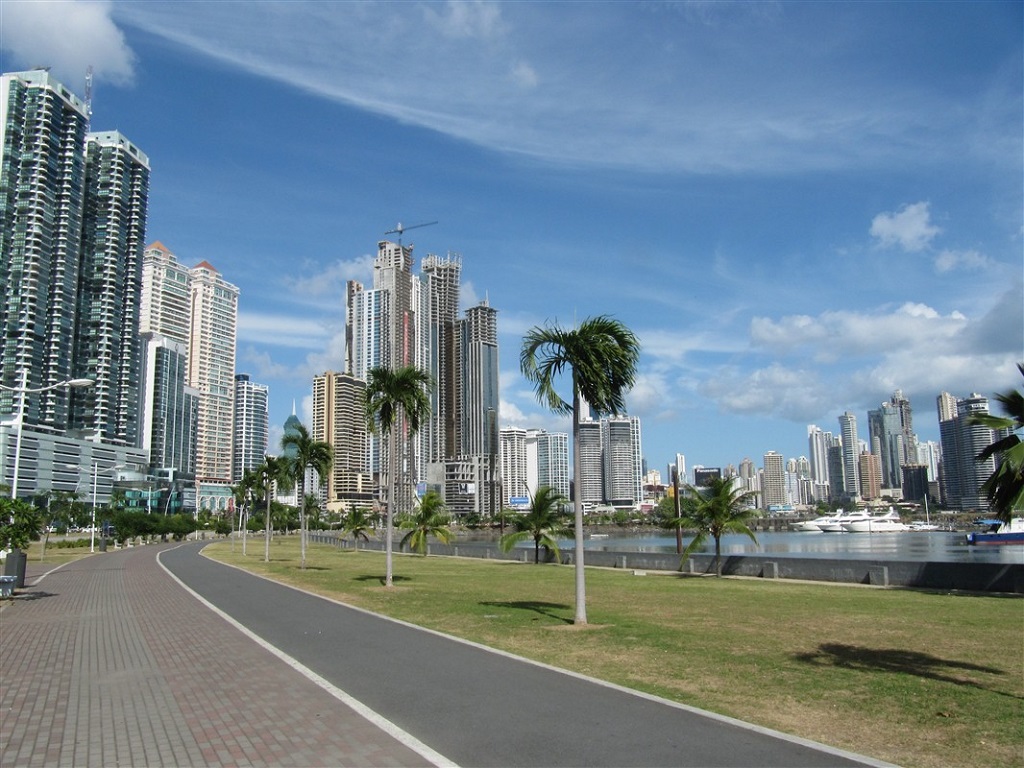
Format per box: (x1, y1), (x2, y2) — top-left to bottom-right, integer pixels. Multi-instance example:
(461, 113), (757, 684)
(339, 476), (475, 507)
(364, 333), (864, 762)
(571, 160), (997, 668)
(0, 70), (148, 501)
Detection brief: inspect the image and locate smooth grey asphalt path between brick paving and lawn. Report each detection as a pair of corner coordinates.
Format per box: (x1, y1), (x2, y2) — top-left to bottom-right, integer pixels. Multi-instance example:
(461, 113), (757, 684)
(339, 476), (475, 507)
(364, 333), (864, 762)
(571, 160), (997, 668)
(160, 545), (885, 768)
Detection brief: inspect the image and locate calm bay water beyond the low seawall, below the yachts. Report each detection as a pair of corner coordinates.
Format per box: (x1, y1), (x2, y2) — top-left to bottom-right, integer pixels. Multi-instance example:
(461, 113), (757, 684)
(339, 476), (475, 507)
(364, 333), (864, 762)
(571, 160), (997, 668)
(569, 530), (1024, 563)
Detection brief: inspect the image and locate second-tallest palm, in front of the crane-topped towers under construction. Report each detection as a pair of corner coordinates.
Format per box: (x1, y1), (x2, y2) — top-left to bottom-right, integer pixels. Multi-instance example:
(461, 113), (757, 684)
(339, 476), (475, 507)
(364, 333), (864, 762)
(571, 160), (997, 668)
(364, 366), (433, 587)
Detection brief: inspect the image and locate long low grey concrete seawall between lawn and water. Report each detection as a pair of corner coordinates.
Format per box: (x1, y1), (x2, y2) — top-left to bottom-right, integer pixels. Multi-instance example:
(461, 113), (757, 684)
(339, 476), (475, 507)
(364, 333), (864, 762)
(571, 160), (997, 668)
(310, 532), (1024, 594)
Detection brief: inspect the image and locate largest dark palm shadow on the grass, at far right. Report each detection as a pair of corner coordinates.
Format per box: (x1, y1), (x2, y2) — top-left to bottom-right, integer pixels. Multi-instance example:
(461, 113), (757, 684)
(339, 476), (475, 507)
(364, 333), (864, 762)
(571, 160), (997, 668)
(794, 643), (1021, 698)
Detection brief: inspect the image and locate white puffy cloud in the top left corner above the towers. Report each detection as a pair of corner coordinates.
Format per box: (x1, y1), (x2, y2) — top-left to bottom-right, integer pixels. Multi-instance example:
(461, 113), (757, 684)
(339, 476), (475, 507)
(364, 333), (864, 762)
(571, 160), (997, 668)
(0, 0), (135, 88)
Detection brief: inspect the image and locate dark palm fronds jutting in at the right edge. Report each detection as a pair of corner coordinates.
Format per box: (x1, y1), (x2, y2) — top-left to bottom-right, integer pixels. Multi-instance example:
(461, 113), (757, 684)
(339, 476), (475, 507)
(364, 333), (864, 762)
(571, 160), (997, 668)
(971, 362), (1024, 522)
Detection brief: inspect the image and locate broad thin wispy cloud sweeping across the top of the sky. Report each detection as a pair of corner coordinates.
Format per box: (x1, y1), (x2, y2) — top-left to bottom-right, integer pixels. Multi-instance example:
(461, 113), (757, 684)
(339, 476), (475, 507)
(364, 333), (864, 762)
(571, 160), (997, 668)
(103, 2), (1019, 173)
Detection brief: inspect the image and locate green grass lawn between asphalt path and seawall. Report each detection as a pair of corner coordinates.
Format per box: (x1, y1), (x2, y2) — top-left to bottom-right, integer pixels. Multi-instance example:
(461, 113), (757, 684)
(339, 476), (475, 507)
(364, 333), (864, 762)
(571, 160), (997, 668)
(205, 538), (1024, 768)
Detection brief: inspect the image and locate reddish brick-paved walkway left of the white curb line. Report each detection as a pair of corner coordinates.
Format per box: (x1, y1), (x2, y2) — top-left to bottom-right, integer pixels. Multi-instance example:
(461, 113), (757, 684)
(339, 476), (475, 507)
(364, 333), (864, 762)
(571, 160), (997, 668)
(0, 546), (431, 768)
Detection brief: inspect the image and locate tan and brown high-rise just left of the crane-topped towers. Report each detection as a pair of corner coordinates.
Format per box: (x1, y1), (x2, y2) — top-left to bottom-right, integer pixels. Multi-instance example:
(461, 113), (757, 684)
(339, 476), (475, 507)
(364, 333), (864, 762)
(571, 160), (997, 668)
(310, 371), (374, 510)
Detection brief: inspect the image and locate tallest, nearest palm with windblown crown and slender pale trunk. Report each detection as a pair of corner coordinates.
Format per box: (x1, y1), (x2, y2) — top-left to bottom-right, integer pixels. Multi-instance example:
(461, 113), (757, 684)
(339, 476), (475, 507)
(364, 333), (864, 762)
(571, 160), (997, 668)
(519, 315), (640, 624)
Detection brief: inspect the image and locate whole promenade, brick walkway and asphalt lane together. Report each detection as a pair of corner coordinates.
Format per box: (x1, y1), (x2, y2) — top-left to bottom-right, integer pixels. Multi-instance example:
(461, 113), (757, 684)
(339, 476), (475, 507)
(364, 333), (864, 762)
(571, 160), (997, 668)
(0, 544), (880, 768)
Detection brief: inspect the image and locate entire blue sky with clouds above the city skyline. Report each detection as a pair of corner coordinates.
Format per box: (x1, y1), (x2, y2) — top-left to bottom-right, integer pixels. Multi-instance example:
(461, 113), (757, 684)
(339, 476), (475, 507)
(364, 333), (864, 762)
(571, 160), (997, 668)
(0, 0), (1024, 479)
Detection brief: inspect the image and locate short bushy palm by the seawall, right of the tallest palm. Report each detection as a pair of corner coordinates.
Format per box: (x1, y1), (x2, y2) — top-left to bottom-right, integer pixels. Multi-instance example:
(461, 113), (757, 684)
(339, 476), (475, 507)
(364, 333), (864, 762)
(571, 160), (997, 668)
(670, 477), (758, 577)
